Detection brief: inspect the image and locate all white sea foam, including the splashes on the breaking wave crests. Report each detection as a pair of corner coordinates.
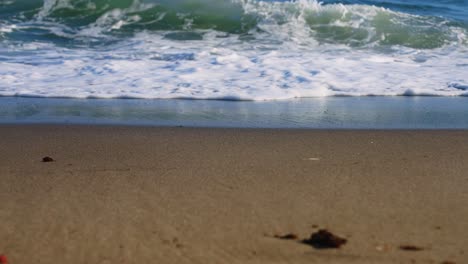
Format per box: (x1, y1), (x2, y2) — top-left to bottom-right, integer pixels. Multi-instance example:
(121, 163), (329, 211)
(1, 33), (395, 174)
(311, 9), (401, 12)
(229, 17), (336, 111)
(0, 0), (468, 100)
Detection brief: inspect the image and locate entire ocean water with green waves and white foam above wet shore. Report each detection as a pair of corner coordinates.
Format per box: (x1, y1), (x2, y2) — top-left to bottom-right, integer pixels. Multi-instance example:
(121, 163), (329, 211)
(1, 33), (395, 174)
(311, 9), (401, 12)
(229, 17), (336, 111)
(0, 0), (468, 101)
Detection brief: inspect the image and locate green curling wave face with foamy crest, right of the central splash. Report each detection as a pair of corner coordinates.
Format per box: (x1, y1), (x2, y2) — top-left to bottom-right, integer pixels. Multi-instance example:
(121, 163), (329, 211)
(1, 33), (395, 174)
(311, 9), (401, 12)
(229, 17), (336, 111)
(306, 5), (460, 49)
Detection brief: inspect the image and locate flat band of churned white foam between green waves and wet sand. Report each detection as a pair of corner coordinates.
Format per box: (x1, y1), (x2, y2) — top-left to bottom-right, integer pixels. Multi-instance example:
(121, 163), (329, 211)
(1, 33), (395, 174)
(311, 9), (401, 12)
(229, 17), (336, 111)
(0, 32), (468, 100)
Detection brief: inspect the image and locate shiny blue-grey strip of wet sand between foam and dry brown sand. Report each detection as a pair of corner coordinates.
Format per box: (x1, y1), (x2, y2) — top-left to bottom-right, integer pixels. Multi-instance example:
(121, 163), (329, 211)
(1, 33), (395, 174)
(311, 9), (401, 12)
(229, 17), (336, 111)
(0, 97), (468, 129)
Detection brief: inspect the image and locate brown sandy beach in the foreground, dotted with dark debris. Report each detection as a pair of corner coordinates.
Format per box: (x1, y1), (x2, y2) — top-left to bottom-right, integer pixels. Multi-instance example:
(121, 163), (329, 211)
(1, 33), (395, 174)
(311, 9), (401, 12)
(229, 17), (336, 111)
(0, 125), (468, 264)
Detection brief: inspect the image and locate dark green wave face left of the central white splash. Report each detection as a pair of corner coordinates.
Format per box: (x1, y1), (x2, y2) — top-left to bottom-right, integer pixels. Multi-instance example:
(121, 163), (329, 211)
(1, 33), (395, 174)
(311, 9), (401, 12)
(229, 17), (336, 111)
(30, 0), (253, 33)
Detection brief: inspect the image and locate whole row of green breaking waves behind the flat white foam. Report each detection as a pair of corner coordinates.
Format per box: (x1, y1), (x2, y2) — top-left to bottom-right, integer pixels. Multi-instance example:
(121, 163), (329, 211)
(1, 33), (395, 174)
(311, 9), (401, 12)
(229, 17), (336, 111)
(0, 0), (467, 49)
